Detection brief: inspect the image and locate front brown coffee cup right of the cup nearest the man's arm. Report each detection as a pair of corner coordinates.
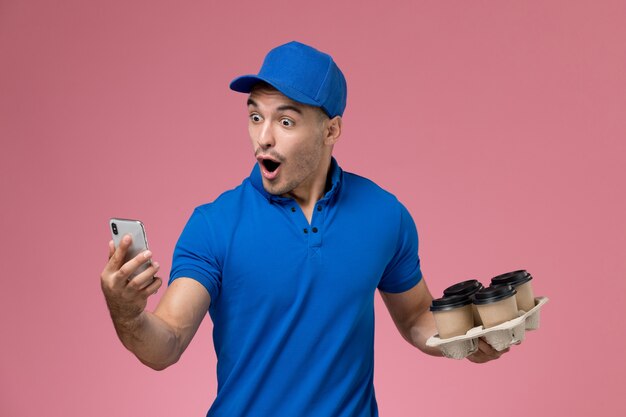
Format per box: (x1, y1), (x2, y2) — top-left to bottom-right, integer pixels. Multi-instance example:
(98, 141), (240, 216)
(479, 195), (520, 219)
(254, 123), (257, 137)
(474, 285), (519, 329)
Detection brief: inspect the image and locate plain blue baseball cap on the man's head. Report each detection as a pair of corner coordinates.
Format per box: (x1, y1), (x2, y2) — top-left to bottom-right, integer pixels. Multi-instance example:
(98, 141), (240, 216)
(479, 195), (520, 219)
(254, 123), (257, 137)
(230, 41), (348, 118)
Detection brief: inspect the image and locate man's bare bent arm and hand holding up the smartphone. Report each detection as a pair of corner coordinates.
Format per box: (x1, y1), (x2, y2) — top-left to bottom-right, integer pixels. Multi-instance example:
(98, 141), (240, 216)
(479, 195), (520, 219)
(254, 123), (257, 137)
(101, 236), (211, 370)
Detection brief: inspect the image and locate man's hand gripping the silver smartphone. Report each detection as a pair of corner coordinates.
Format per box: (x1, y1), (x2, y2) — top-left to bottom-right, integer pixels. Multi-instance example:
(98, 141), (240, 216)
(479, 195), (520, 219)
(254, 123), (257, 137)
(100, 235), (162, 333)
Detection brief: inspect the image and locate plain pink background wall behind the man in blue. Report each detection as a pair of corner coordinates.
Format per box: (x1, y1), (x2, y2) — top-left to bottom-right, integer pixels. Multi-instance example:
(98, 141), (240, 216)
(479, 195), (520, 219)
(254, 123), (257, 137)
(0, 0), (626, 417)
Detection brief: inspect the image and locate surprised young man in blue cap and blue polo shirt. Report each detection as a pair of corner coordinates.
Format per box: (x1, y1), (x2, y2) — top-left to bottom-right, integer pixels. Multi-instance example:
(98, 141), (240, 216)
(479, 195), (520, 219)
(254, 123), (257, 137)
(101, 42), (501, 417)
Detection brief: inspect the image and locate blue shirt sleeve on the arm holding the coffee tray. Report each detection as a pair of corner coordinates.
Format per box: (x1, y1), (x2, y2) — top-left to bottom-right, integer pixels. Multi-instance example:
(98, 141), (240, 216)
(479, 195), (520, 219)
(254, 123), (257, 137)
(378, 203), (422, 293)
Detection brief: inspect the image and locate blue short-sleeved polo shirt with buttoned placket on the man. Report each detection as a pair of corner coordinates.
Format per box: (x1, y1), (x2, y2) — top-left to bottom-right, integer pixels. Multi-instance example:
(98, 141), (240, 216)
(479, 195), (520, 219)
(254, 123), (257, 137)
(170, 159), (422, 417)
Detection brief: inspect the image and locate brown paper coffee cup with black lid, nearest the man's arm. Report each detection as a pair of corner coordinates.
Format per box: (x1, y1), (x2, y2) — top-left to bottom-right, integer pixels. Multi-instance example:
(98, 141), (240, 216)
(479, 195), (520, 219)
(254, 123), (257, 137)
(430, 296), (474, 339)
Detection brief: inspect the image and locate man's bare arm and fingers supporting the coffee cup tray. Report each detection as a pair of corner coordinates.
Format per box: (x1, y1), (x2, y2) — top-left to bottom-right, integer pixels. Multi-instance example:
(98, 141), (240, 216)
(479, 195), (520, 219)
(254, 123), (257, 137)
(380, 279), (509, 363)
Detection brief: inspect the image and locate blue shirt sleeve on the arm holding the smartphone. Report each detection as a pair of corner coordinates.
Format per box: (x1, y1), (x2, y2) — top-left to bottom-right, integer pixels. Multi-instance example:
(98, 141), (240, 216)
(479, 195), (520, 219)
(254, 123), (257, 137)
(168, 206), (222, 300)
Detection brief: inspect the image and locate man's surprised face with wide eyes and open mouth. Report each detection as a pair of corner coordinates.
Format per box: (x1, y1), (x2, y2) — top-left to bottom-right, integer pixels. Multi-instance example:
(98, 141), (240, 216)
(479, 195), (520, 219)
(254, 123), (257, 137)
(248, 87), (332, 197)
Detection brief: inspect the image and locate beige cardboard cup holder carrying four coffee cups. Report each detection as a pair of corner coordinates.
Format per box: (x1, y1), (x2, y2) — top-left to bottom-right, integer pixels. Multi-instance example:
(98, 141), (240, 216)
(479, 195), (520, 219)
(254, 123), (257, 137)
(426, 297), (548, 359)
